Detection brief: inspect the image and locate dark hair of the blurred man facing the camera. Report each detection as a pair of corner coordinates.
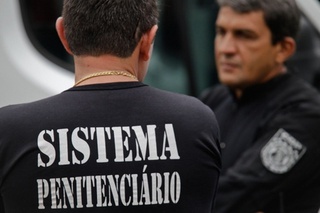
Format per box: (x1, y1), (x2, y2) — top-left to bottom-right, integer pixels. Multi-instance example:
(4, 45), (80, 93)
(217, 0), (300, 44)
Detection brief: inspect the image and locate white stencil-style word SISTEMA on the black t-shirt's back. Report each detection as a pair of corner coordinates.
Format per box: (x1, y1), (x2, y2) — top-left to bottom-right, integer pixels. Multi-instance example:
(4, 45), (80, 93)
(37, 124), (180, 168)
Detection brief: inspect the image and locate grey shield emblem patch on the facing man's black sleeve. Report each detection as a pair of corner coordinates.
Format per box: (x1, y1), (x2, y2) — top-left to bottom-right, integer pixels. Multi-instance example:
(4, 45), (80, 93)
(260, 129), (307, 174)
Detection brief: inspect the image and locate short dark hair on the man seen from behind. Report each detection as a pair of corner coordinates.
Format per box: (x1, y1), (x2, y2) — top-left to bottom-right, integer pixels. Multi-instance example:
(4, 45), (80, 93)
(62, 0), (159, 58)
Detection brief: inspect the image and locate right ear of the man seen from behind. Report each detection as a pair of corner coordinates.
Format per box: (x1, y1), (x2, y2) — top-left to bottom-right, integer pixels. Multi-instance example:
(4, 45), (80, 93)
(140, 25), (158, 61)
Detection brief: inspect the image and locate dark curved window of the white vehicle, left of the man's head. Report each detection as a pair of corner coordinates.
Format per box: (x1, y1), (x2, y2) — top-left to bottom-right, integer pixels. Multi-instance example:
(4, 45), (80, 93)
(20, 0), (73, 71)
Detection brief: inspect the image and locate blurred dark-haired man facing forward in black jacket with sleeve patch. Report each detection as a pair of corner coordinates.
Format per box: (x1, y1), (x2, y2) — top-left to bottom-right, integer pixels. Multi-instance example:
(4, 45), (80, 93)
(201, 0), (320, 213)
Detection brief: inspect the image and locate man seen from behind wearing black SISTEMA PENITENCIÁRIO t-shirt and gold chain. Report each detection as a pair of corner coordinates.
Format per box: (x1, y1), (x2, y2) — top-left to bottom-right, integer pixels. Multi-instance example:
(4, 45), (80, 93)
(0, 0), (221, 213)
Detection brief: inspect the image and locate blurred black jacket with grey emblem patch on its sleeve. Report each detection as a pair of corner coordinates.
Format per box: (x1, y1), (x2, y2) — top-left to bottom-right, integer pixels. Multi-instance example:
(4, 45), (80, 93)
(202, 74), (320, 213)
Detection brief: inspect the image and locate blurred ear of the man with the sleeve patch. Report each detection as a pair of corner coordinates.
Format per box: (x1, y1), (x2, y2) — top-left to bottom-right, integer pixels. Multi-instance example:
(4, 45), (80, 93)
(276, 37), (296, 64)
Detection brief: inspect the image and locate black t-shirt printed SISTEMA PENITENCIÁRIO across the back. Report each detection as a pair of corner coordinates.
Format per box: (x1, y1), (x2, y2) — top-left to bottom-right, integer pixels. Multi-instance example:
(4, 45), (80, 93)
(0, 82), (221, 213)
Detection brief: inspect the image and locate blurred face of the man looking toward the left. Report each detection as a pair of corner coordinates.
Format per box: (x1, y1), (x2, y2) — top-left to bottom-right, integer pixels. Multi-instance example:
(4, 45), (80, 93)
(215, 7), (279, 89)
